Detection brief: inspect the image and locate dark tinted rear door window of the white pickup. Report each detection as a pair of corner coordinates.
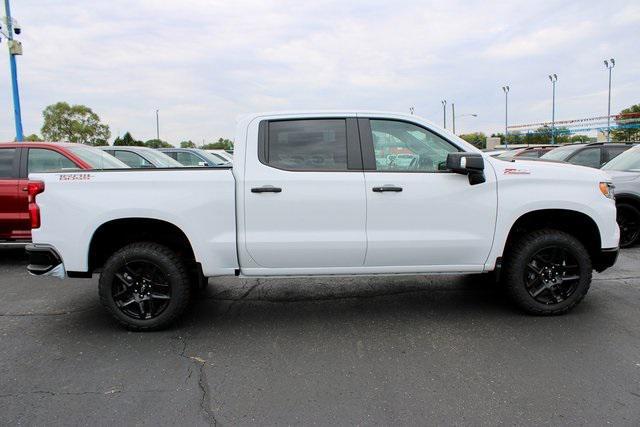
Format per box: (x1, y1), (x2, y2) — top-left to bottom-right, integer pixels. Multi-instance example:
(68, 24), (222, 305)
(267, 119), (347, 171)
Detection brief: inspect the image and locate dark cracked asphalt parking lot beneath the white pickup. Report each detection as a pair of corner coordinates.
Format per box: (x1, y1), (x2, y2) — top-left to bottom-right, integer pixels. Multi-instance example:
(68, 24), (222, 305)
(0, 248), (640, 425)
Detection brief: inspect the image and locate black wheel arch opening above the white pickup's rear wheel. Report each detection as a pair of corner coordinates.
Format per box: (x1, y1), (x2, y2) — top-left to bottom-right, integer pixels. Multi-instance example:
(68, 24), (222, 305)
(88, 217), (196, 273)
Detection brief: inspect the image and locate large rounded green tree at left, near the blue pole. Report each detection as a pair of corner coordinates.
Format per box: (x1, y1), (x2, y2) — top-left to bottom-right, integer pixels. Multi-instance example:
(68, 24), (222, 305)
(41, 102), (111, 145)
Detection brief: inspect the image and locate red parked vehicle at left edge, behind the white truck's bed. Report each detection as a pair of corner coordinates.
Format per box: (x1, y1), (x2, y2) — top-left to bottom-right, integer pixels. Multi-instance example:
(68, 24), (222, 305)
(0, 142), (127, 241)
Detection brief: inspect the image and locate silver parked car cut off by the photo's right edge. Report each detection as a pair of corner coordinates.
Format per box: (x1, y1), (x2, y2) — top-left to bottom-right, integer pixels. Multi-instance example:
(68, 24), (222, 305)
(602, 146), (640, 248)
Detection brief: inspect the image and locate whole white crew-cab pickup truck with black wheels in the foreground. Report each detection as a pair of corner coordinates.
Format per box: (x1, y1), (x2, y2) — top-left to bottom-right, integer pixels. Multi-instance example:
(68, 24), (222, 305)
(27, 111), (619, 330)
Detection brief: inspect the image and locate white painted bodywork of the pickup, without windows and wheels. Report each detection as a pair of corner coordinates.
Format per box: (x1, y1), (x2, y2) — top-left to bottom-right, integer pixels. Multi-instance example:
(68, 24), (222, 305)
(30, 111), (619, 276)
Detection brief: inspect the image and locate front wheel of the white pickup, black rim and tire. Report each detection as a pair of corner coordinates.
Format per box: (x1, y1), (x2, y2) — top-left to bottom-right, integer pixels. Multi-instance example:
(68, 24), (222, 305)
(504, 229), (592, 315)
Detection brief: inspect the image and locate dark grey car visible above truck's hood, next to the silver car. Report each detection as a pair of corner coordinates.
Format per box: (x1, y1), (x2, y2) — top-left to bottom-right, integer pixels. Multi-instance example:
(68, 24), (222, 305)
(540, 142), (632, 169)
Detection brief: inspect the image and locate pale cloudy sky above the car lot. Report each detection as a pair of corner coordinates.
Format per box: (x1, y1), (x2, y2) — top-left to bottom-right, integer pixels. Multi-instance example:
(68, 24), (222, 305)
(0, 0), (640, 144)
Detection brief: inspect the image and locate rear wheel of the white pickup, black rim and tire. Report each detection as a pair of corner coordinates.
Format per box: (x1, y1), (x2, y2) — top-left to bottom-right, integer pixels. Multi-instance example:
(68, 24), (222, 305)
(99, 242), (191, 331)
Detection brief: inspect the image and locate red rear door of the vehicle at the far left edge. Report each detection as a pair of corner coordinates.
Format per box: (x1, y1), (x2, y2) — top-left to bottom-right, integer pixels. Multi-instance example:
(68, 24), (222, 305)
(0, 148), (21, 239)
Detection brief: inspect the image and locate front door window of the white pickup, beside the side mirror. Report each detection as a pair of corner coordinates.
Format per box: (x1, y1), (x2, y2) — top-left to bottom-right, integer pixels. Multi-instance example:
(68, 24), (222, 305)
(370, 120), (459, 172)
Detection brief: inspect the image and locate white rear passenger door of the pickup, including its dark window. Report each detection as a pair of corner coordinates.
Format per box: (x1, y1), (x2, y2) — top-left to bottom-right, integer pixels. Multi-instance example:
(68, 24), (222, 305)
(242, 117), (366, 274)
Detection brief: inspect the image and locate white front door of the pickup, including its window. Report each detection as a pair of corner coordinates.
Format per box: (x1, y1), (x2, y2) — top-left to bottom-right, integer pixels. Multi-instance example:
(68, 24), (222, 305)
(359, 118), (497, 272)
